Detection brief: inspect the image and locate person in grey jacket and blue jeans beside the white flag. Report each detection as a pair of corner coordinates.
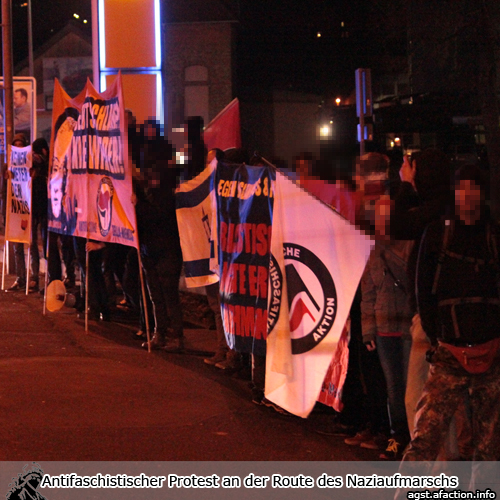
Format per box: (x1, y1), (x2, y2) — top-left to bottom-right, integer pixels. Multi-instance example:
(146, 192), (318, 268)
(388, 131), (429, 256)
(362, 199), (412, 459)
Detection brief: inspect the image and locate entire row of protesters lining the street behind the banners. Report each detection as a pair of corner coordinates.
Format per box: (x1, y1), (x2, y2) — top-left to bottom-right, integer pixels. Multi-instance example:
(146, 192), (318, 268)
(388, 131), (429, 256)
(1, 112), (500, 461)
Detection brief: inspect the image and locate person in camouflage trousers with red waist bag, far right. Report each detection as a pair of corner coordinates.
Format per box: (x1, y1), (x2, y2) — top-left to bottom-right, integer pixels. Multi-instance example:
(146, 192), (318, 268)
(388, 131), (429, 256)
(404, 165), (500, 461)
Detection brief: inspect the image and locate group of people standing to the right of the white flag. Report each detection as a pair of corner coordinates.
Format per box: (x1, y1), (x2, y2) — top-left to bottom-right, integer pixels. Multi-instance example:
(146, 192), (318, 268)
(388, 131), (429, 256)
(308, 149), (500, 461)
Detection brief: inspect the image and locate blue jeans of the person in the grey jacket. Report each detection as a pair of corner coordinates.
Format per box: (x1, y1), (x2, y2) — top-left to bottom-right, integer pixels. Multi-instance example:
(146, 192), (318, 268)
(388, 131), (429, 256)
(376, 335), (411, 438)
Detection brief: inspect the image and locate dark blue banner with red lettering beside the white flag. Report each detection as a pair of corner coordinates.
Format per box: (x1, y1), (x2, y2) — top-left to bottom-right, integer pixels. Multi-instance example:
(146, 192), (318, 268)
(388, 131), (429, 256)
(215, 163), (275, 356)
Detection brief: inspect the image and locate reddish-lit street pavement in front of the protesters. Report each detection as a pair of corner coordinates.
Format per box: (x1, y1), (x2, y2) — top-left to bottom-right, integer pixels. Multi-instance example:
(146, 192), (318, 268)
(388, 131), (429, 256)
(0, 266), (378, 461)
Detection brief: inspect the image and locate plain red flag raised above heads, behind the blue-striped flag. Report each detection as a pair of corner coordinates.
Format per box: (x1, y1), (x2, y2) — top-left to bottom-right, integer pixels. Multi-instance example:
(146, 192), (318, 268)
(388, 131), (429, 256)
(203, 98), (241, 151)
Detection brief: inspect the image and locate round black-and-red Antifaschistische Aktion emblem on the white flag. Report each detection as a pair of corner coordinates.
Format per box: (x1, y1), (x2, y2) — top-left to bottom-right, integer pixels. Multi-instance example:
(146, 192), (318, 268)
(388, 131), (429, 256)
(268, 243), (337, 354)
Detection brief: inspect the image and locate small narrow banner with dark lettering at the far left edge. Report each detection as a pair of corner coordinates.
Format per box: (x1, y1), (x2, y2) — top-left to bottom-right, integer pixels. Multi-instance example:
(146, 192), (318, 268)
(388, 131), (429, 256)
(5, 146), (32, 243)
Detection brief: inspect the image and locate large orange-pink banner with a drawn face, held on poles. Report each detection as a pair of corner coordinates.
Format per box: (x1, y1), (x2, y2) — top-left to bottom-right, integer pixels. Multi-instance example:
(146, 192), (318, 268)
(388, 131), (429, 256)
(48, 77), (138, 247)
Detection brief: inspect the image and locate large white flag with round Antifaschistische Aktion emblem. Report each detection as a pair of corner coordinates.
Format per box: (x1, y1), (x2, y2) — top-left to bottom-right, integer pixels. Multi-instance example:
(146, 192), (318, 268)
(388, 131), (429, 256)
(265, 172), (373, 417)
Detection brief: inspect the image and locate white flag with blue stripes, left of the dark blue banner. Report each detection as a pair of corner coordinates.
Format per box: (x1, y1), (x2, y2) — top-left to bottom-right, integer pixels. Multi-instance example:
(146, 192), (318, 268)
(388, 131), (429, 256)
(176, 159), (219, 288)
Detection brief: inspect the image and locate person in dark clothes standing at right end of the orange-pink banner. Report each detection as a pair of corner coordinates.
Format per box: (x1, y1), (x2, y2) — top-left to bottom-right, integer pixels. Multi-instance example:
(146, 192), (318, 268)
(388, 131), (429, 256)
(136, 122), (184, 352)
